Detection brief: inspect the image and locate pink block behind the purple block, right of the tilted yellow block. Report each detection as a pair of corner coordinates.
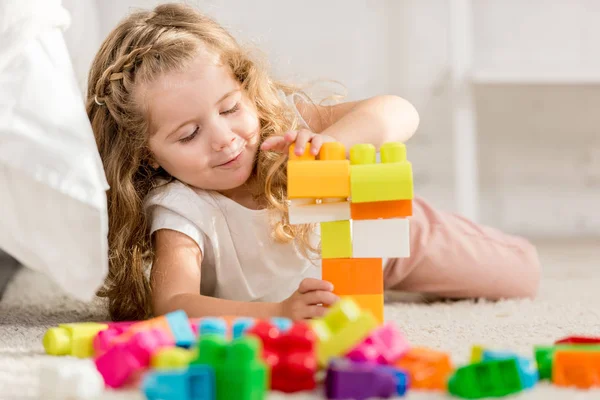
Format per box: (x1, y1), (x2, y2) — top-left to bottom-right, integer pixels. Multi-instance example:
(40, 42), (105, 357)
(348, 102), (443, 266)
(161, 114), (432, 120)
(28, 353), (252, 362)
(347, 323), (410, 364)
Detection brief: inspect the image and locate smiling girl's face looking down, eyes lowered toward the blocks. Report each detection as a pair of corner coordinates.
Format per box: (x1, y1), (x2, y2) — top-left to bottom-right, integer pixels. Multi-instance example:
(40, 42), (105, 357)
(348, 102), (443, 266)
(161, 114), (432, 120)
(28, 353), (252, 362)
(143, 55), (260, 193)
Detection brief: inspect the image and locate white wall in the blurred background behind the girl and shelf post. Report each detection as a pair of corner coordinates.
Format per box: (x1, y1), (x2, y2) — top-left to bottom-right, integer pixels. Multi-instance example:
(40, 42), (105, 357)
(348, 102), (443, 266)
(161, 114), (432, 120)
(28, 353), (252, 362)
(65, 0), (600, 236)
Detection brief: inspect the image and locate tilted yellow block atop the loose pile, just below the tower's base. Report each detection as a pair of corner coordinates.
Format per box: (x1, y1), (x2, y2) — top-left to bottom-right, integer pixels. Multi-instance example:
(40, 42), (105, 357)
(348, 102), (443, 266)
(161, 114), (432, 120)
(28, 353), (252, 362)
(310, 297), (377, 367)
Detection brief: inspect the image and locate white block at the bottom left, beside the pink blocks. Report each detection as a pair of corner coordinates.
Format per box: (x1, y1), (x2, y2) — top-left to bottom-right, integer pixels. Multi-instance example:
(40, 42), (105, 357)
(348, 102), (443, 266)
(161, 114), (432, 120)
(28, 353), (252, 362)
(37, 358), (104, 399)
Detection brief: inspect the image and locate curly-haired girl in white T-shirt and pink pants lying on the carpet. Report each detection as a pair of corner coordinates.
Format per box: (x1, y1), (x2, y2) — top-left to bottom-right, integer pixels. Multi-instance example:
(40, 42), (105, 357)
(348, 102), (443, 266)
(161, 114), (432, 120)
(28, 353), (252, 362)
(87, 4), (539, 320)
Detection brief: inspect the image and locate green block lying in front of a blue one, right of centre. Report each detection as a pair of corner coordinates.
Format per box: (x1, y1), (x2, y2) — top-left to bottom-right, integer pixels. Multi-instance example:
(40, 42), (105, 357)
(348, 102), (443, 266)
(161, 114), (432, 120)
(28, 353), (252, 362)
(448, 358), (523, 399)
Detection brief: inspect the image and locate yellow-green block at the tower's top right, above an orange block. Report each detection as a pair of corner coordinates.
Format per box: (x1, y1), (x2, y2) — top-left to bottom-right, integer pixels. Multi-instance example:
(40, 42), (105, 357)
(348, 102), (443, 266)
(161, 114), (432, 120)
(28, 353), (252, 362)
(350, 142), (414, 203)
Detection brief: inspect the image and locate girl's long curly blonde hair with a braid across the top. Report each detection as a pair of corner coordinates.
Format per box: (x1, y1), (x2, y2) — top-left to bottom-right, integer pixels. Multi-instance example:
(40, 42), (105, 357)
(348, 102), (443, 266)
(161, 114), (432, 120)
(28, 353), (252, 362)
(86, 4), (317, 320)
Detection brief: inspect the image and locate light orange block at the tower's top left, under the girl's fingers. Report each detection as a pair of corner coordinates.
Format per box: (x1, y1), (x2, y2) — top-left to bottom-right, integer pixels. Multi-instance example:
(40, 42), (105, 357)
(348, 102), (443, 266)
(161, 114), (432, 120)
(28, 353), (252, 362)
(287, 142), (350, 199)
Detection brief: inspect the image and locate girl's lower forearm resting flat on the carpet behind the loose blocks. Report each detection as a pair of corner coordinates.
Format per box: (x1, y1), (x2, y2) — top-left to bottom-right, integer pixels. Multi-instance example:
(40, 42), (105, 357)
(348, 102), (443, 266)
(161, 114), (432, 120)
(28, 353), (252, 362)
(156, 293), (280, 319)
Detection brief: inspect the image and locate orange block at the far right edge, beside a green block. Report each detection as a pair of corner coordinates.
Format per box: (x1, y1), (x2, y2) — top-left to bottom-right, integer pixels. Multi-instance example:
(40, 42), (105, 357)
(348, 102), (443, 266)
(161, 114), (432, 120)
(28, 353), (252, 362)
(552, 349), (600, 389)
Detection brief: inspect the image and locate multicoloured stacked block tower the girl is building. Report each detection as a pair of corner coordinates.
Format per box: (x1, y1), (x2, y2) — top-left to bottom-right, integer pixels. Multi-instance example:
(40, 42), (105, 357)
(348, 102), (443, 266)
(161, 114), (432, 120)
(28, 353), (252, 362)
(287, 142), (413, 322)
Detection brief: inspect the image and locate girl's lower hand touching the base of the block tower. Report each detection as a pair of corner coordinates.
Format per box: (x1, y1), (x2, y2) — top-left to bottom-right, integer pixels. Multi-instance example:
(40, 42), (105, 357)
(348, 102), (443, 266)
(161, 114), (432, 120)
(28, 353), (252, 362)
(279, 278), (338, 321)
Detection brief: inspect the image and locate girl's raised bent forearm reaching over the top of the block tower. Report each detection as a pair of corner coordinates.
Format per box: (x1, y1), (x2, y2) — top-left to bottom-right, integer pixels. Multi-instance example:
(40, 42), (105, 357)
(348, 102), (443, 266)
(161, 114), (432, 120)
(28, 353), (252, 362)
(321, 96), (419, 149)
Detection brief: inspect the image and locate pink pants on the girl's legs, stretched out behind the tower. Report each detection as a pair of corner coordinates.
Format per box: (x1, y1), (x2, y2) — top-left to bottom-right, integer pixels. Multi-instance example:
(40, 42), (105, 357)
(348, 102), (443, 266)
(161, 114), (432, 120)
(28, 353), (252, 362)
(384, 198), (540, 299)
